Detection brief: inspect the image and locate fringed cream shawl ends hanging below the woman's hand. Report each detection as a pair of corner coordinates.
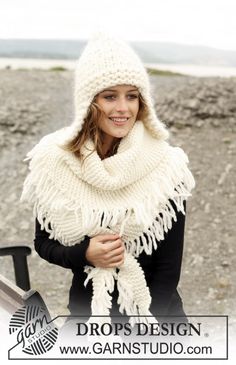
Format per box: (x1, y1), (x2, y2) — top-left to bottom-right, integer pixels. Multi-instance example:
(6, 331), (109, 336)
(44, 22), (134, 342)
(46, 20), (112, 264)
(84, 254), (158, 326)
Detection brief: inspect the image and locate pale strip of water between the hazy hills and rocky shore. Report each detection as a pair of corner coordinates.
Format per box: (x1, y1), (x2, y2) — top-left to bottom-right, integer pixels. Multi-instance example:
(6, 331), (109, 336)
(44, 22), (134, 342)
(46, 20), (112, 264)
(0, 58), (236, 77)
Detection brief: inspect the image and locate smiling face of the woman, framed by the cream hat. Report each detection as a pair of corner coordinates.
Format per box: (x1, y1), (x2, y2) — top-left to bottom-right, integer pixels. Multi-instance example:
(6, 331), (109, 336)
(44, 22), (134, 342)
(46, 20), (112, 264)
(96, 85), (139, 140)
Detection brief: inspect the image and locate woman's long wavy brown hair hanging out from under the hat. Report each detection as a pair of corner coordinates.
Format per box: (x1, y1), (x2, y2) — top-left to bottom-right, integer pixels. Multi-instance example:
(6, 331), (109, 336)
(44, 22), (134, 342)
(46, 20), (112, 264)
(63, 94), (148, 159)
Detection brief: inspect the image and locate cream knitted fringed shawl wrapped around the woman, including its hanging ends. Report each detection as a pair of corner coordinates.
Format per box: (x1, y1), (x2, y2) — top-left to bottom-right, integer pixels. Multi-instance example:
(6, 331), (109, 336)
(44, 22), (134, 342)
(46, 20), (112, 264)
(21, 121), (195, 322)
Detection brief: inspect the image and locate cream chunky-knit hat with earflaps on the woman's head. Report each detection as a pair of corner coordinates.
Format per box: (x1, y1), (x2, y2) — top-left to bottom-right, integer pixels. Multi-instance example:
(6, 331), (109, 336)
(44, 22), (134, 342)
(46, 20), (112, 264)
(65, 32), (169, 141)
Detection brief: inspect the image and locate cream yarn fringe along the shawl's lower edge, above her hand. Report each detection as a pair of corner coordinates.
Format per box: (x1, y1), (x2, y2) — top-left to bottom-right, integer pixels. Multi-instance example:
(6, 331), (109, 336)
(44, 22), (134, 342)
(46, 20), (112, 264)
(21, 154), (193, 250)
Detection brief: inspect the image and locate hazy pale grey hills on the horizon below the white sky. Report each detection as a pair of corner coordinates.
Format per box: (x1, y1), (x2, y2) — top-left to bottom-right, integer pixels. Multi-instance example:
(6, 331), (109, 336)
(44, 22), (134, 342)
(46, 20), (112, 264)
(0, 39), (236, 67)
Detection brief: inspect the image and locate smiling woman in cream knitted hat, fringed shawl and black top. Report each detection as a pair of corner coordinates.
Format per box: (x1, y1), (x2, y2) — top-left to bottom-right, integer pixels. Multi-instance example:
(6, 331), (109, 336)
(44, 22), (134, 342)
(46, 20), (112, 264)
(21, 34), (194, 322)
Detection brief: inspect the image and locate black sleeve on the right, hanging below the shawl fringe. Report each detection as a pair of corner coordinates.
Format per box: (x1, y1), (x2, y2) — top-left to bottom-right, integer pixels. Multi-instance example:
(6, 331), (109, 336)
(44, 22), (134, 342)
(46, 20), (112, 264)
(142, 202), (186, 314)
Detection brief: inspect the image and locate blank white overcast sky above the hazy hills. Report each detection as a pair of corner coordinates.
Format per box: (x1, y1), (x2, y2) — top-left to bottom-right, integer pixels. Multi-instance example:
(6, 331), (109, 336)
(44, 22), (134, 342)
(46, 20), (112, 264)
(0, 0), (236, 50)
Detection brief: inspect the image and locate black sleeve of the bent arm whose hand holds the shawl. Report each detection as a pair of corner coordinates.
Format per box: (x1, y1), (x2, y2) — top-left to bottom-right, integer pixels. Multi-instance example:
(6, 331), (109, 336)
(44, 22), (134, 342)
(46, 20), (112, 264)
(34, 219), (91, 270)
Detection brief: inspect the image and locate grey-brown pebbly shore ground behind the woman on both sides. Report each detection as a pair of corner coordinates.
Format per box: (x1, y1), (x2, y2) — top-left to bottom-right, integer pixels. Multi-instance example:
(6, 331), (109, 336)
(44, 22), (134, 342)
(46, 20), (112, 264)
(0, 70), (236, 326)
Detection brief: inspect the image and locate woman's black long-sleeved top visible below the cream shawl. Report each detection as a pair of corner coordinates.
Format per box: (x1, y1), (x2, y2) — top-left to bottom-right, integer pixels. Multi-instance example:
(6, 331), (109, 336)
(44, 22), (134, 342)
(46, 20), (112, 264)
(34, 199), (187, 321)
